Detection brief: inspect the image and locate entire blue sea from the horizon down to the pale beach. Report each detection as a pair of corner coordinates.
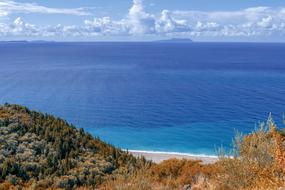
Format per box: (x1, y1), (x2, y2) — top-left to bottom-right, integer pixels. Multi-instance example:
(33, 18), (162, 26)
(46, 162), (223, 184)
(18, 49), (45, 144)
(0, 42), (285, 154)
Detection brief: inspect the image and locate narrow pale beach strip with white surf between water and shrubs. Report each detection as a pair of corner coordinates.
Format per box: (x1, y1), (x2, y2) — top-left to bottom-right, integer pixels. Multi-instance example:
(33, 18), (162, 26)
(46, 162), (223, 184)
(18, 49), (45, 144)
(129, 150), (218, 164)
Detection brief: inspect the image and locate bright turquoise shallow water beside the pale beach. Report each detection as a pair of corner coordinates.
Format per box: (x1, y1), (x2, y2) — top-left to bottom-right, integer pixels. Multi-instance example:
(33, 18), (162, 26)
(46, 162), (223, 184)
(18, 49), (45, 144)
(87, 121), (251, 155)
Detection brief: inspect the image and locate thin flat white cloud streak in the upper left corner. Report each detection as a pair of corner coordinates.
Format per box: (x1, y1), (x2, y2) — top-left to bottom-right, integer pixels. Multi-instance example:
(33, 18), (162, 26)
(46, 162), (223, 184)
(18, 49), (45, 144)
(0, 0), (89, 16)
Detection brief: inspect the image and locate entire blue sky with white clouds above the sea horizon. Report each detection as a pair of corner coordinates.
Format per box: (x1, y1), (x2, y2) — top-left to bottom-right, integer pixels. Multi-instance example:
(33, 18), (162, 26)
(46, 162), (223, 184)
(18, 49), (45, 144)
(0, 0), (285, 42)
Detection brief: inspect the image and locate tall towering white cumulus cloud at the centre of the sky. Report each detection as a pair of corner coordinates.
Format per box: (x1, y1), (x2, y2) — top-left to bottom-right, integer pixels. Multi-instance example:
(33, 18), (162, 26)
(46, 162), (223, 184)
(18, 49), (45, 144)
(82, 0), (190, 35)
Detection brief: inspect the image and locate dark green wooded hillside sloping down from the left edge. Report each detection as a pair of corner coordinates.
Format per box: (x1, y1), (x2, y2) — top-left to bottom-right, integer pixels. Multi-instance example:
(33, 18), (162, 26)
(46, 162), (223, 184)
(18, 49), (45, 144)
(0, 104), (149, 189)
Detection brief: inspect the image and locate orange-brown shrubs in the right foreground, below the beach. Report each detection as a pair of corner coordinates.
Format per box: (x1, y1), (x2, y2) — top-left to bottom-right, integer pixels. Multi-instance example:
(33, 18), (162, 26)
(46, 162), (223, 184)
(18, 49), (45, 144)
(102, 116), (285, 190)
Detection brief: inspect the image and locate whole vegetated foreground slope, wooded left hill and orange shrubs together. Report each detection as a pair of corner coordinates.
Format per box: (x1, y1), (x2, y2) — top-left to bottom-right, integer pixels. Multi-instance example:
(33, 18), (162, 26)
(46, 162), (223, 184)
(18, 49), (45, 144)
(0, 104), (285, 190)
